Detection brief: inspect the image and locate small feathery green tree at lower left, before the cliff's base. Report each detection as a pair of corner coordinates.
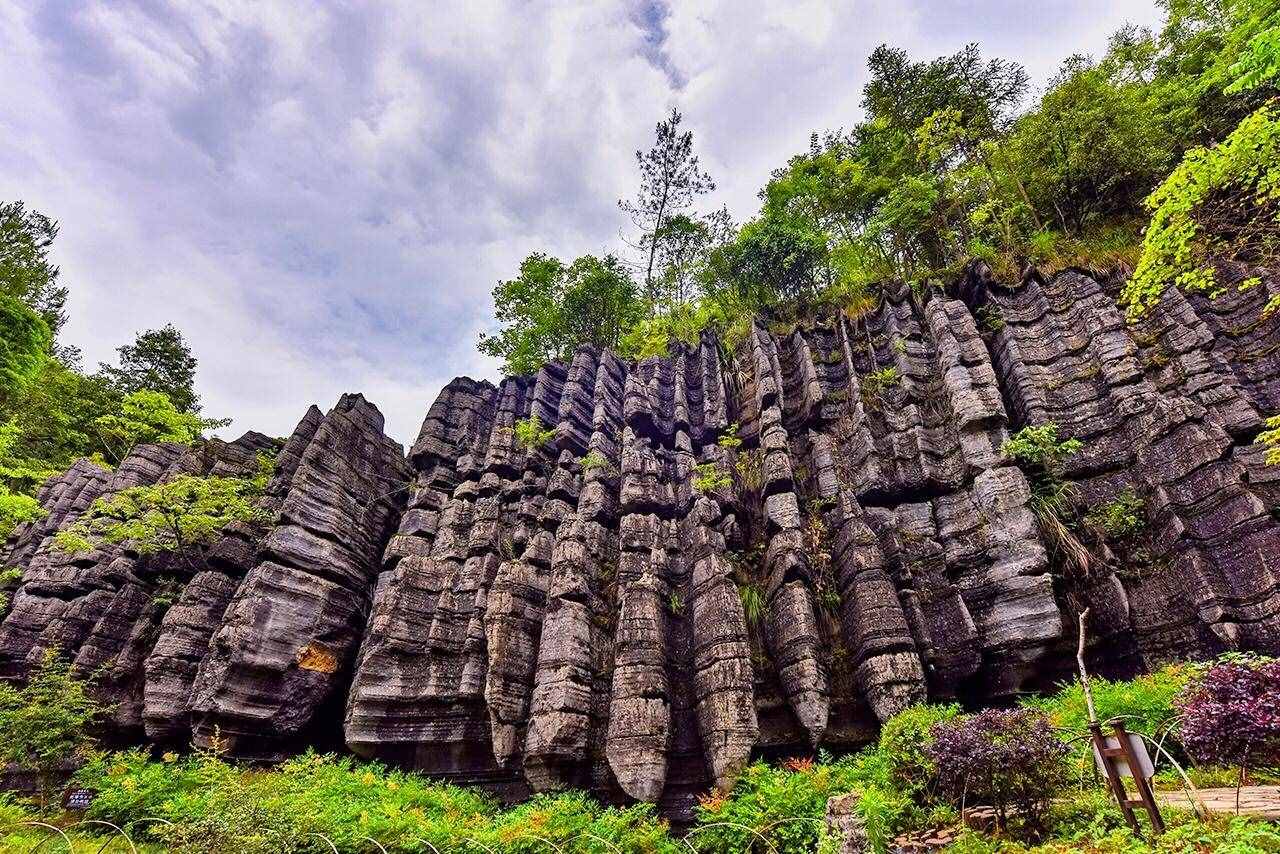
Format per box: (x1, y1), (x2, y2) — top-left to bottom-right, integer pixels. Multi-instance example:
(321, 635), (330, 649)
(0, 649), (106, 812)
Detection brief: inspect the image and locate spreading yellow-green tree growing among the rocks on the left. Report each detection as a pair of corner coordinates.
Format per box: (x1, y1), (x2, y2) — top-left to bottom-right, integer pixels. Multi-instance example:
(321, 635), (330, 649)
(54, 457), (270, 557)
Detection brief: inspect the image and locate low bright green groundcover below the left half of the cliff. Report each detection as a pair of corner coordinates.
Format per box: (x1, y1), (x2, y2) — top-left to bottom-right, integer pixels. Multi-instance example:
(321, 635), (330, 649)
(77, 750), (676, 854)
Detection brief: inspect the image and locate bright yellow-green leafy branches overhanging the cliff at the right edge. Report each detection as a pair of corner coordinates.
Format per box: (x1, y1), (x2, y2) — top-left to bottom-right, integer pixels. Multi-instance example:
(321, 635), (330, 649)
(1124, 106), (1280, 316)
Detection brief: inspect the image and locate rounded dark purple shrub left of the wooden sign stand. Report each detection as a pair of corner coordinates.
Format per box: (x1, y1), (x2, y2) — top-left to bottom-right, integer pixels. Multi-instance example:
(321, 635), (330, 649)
(925, 709), (1068, 830)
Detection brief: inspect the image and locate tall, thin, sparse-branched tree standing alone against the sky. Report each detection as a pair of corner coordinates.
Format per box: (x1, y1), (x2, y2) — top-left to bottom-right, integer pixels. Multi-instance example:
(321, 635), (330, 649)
(618, 108), (716, 306)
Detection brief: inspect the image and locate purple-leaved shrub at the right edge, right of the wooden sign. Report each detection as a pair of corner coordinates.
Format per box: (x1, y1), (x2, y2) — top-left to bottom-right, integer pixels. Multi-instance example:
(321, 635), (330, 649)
(1176, 661), (1280, 771)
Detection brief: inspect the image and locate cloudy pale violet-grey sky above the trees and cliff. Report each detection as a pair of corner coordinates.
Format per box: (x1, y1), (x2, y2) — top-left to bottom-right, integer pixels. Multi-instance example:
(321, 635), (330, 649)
(0, 0), (1160, 444)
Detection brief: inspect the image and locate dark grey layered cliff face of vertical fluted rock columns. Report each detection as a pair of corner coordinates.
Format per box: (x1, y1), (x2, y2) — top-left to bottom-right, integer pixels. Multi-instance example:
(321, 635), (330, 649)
(0, 266), (1280, 813)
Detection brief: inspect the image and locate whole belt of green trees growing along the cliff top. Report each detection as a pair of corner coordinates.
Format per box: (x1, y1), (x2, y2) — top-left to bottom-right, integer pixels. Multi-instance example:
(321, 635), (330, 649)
(481, 0), (1280, 363)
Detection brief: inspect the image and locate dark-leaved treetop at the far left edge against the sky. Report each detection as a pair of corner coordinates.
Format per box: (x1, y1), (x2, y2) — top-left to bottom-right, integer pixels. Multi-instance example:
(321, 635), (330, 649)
(0, 201), (67, 335)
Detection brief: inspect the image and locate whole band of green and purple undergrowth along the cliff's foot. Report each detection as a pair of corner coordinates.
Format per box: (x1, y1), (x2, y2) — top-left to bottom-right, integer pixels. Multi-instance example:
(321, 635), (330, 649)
(0, 660), (1280, 854)
